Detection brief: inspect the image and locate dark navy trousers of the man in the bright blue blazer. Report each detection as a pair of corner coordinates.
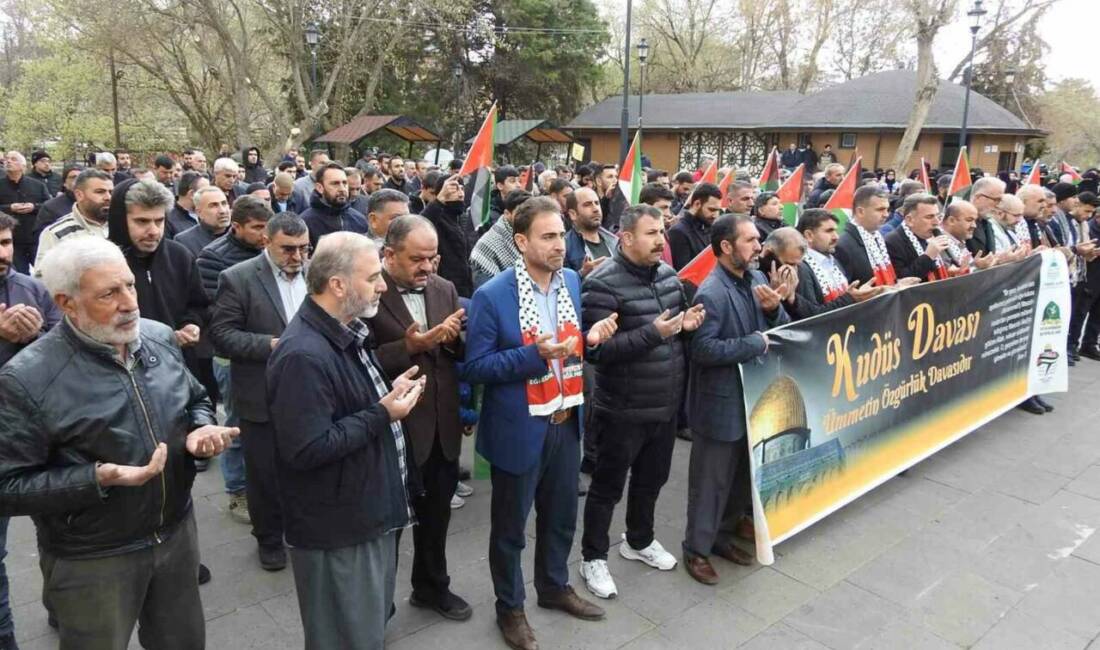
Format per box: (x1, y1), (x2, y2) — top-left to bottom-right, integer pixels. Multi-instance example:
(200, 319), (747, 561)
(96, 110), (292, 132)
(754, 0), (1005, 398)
(488, 411), (580, 613)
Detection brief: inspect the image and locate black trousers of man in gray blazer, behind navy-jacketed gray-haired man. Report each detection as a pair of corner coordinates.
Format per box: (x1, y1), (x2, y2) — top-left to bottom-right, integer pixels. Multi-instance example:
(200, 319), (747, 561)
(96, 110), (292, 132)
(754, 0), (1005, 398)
(240, 418), (283, 548)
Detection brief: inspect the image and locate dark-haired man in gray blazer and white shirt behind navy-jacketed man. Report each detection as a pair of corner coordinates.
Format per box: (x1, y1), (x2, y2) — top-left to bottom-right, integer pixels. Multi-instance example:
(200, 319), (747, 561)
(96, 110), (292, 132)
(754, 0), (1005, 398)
(210, 212), (309, 571)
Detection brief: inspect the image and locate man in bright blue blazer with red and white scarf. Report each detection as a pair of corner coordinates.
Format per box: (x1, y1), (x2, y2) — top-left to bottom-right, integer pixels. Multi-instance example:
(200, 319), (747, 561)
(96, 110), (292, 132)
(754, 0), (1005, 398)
(460, 197), (617, 650)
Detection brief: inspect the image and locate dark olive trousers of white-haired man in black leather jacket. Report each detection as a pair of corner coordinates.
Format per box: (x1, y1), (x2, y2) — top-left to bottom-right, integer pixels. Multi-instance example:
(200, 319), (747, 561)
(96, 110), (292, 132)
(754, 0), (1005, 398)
(45, 514), (206, 650)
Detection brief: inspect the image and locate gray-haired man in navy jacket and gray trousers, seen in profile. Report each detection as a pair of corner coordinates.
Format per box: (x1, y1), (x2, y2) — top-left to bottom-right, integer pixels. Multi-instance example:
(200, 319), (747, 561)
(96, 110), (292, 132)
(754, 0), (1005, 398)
(267, 232), (426, 650)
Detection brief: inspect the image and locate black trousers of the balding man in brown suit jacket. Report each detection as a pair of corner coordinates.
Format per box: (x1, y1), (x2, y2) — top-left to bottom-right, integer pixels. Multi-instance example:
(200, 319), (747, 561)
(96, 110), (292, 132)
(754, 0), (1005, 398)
(397, 436), (459, 603)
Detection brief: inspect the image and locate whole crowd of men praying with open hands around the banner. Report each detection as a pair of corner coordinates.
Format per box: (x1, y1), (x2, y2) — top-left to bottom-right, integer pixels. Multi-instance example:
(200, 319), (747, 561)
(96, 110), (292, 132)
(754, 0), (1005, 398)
(0, 145), (1100, 650)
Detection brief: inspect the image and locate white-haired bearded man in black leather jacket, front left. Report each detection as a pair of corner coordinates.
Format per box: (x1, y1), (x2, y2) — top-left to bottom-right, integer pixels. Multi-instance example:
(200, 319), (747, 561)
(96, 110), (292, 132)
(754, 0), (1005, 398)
(0, 238), (238, 650)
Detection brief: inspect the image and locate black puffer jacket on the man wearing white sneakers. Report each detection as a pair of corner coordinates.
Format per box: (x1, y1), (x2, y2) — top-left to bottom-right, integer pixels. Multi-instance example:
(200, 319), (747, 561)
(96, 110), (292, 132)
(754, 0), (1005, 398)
(581, 250), (688, 422)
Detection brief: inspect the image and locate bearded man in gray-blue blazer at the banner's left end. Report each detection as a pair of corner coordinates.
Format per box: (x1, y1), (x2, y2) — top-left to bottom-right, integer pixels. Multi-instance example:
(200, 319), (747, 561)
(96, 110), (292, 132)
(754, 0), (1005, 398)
(683, 214), (794, 585)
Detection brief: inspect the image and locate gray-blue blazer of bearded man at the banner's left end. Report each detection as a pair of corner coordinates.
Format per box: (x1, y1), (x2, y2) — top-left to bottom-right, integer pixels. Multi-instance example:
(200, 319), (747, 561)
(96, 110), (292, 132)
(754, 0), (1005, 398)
(688, 265), (790, 442)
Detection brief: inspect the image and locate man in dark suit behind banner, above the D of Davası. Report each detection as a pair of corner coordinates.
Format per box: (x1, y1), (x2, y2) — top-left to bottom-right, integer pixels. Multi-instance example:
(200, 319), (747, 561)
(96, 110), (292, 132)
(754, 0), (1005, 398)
(884, 194), (948, 282)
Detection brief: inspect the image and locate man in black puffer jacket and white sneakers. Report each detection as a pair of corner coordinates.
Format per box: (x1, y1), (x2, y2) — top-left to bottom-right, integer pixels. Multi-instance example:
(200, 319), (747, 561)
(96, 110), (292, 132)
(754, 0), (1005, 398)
(581, 205), (704, 598)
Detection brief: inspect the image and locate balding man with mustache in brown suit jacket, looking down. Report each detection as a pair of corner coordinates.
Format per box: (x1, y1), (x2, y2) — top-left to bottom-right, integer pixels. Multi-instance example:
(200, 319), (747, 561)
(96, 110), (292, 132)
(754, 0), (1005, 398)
(369, 214), (473, 620)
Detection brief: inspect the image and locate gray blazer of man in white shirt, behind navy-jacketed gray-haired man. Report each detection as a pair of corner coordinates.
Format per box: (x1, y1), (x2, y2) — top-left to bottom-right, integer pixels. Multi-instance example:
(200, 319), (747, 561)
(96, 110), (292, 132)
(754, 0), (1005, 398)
(209, 254), (294, 422)
